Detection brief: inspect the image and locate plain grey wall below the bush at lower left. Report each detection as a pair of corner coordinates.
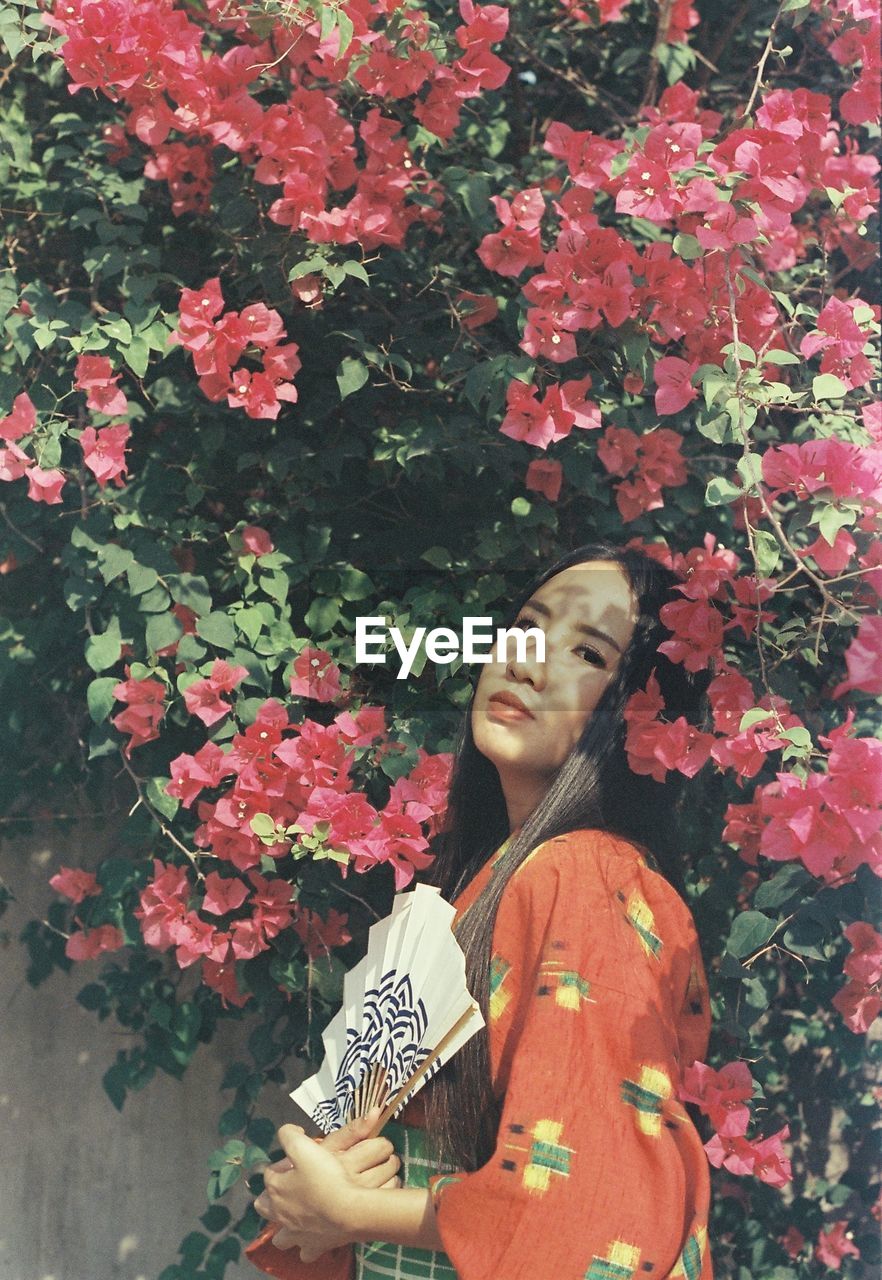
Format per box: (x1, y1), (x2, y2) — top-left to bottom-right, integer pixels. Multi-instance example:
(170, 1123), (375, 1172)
(0, 828), (293, 1280)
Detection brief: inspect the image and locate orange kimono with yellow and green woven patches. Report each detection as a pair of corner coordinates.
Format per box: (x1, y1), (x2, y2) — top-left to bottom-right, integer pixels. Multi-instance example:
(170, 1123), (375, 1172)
(248, 829), (712, 1280)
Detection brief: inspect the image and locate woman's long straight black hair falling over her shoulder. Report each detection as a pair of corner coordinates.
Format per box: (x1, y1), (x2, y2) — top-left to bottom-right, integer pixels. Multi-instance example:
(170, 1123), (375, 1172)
(424, 543), (707, 1170)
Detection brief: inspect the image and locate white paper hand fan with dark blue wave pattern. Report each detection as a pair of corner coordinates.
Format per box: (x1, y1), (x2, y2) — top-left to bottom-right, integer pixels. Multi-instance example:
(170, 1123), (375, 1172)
(291, 884), (484, 1133)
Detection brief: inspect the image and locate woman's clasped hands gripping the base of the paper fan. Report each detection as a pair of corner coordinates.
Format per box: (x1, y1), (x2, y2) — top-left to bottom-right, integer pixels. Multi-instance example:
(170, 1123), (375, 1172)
(255, 1114), (401, 1262)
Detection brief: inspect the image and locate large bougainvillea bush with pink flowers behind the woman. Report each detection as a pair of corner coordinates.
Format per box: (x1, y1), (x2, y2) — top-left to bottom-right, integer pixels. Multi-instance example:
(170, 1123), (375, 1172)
(0, 0), (882, 1280)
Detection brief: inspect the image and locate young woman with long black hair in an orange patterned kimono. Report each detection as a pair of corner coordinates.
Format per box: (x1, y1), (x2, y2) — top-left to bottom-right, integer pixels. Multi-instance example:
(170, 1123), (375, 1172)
(250, 544), (712, 1280)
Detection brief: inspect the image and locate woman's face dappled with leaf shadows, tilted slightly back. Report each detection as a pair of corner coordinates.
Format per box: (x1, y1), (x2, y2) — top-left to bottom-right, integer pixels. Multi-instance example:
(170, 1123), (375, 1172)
(471, 561), (635, 815)
